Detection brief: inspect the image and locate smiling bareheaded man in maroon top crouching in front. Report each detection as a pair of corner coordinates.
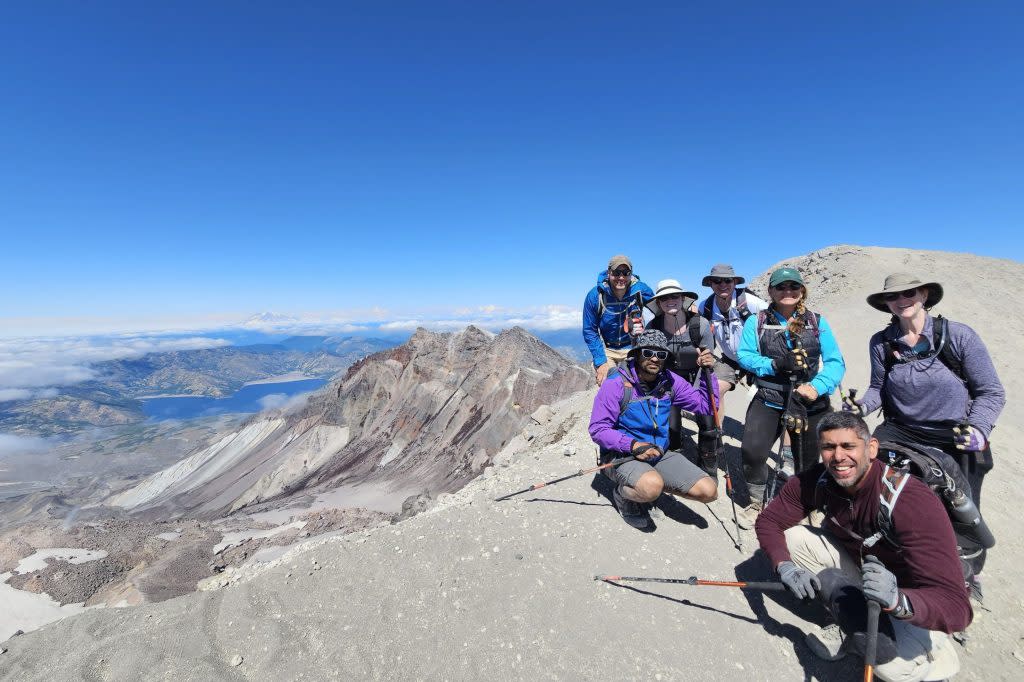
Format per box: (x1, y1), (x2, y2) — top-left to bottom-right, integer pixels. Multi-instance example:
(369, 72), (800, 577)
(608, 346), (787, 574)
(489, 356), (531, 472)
(756, 412), (973, 682)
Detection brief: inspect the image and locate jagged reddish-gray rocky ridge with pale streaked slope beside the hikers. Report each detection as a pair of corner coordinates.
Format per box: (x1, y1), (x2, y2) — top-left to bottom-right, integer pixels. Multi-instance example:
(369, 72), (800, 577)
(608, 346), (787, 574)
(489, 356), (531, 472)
(109, 327), (590, 517)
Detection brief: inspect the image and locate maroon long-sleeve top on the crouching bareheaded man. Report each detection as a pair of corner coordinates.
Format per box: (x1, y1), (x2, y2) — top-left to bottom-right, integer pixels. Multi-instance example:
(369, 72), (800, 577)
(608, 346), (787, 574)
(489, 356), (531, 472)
(755, 460), (974, 633)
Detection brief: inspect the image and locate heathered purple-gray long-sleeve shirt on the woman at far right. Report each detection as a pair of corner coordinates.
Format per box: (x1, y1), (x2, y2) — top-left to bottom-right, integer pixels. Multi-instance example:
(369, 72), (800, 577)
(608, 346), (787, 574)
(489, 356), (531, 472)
(863, 315), (1007, 438)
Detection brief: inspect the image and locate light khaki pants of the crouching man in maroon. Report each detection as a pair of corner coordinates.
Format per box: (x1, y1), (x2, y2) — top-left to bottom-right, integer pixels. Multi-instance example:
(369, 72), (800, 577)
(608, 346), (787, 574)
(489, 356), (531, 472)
(785, 525), (959, 682)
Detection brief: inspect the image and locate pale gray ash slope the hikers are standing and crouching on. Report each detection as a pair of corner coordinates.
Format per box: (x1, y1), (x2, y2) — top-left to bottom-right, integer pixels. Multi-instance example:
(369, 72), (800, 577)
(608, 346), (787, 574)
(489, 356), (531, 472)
(0, 247), (1024, 682)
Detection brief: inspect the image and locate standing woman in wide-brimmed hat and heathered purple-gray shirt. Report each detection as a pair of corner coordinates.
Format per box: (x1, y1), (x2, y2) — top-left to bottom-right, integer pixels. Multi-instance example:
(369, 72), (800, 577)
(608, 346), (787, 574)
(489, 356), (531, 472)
(844, 272), (1006, 599)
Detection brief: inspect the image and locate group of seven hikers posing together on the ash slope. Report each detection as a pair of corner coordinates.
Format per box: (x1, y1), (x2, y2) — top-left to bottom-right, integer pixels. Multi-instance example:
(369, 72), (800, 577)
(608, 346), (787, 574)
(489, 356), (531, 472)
(583, 255), (1005, 680)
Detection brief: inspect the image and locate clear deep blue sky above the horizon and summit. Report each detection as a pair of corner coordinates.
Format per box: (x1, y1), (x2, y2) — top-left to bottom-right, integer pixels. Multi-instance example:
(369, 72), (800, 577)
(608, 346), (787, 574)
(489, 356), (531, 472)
(0, 1), (1024, 331)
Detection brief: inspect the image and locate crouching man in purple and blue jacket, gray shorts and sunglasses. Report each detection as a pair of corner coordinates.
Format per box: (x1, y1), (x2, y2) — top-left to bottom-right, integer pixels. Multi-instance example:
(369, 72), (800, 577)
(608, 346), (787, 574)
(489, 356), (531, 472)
(590, 330), (718, 529)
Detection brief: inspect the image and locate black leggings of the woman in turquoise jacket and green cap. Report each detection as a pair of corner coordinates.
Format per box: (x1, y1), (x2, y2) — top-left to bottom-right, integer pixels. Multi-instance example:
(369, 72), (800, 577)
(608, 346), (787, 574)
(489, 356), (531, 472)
(741, 397), (830, 485)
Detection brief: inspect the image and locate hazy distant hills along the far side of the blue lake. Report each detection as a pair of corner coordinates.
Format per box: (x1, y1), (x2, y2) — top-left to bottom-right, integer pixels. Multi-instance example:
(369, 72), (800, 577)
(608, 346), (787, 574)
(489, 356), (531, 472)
(0, 336), (394, 435)
